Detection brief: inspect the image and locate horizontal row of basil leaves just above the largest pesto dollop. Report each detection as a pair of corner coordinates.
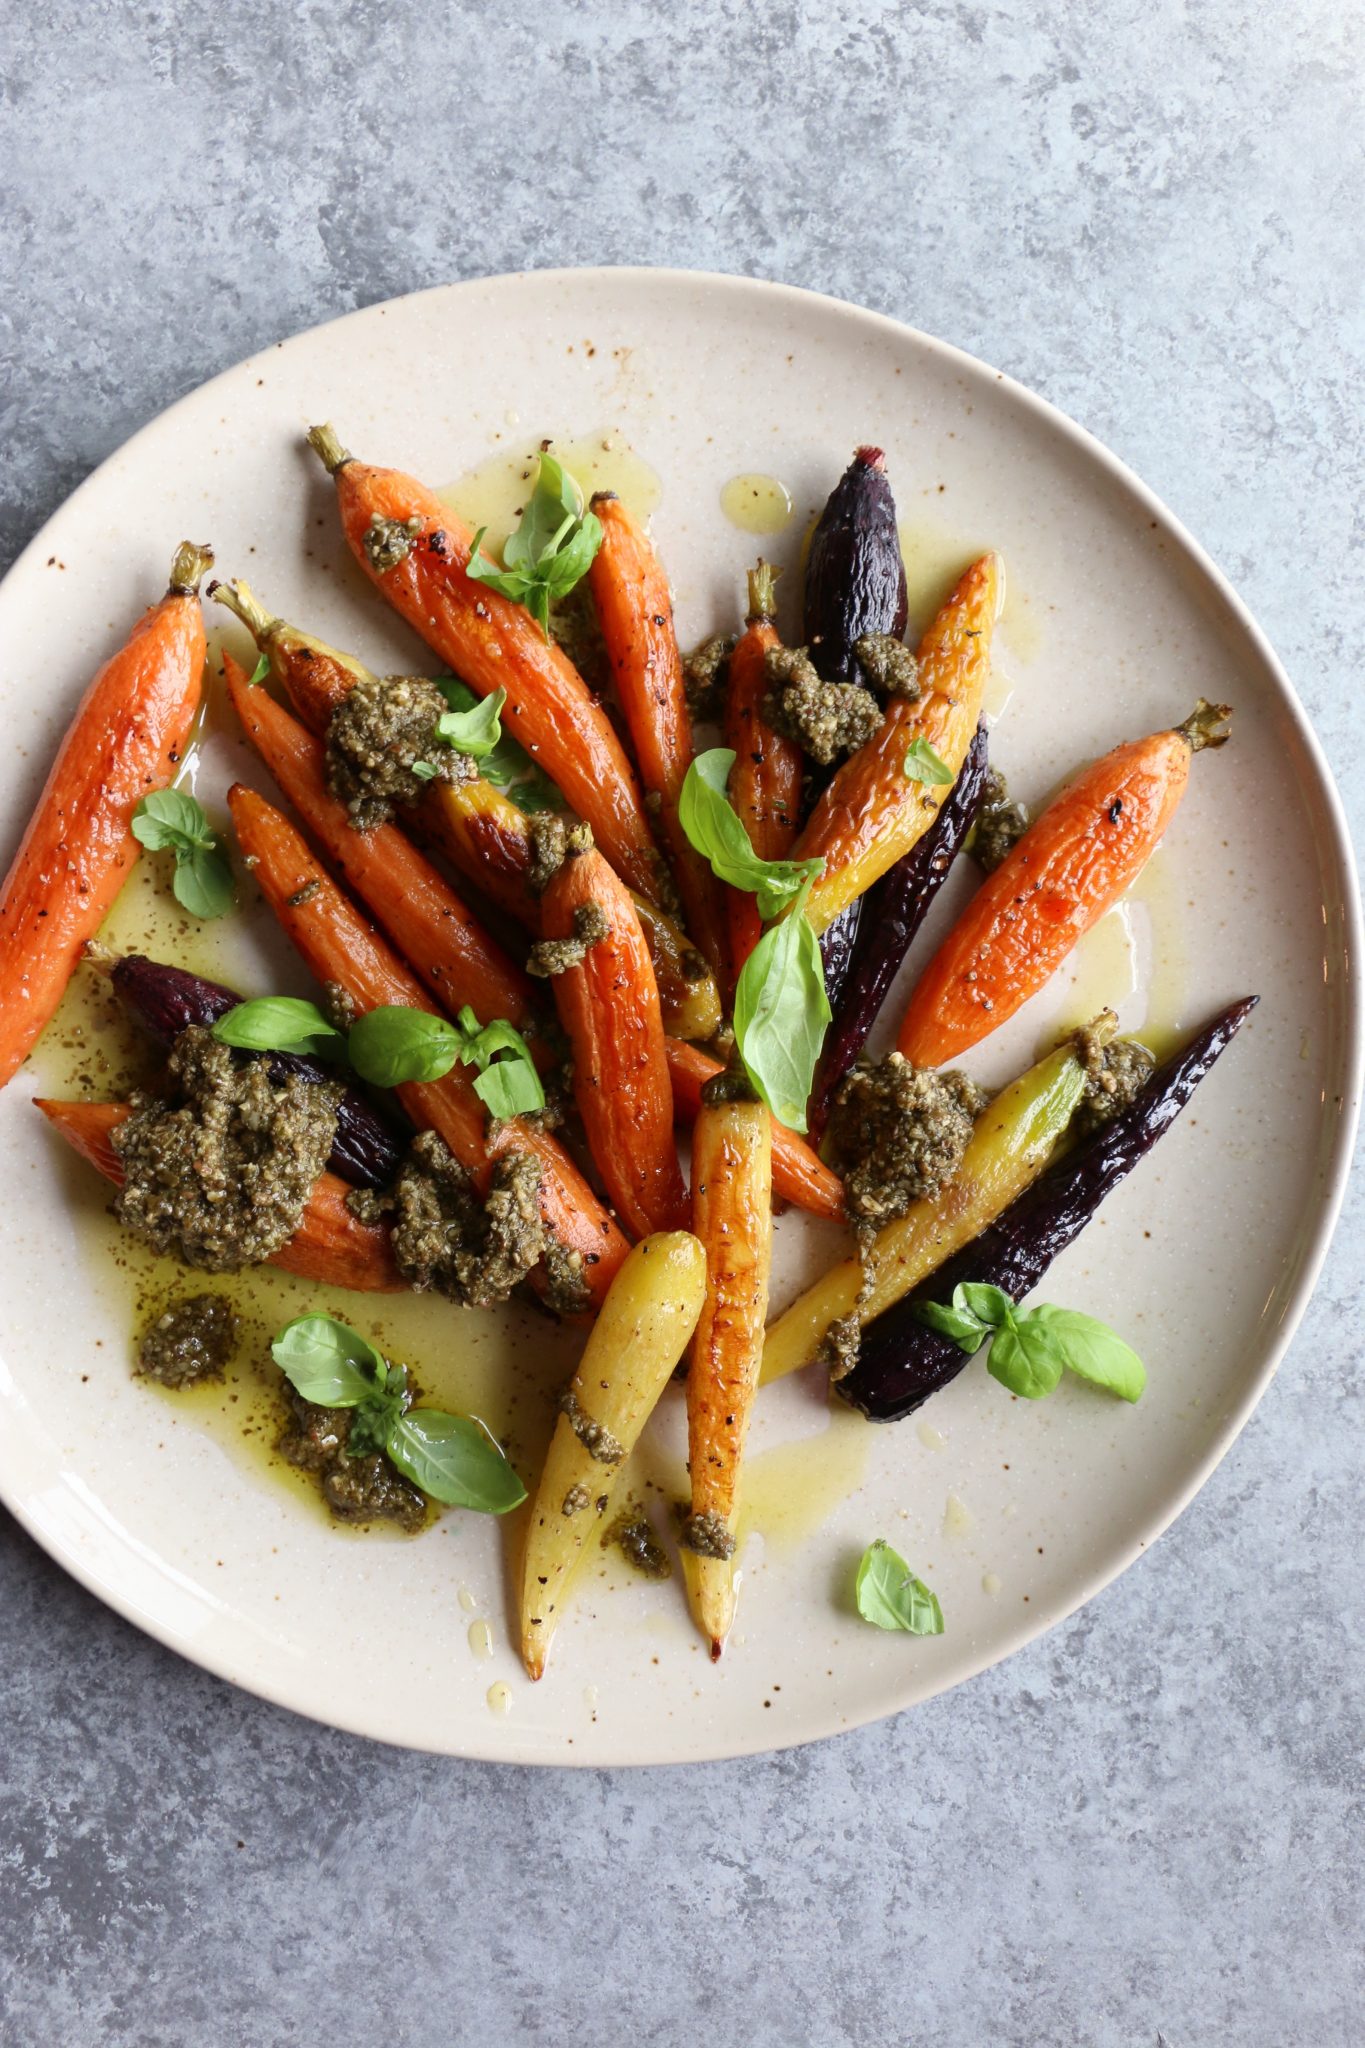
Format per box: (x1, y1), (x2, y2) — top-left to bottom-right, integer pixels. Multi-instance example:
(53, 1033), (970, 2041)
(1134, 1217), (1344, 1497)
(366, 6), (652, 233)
(213, 995), (544, 1118)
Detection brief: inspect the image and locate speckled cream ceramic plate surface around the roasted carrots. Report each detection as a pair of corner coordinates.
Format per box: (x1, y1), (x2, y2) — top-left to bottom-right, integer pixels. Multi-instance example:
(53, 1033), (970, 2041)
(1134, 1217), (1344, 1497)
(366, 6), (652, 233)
(0, 270), (1359, 1763)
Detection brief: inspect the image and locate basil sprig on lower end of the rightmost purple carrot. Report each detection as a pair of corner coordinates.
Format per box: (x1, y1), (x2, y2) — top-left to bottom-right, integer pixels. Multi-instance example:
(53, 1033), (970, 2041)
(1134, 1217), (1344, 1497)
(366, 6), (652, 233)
(915, 1280), (1146, 1401)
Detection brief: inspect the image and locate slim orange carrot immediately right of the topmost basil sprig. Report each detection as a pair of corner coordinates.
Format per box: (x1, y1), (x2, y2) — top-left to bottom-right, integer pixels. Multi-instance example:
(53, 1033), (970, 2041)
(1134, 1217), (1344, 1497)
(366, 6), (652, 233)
(587, 492), (724, 973)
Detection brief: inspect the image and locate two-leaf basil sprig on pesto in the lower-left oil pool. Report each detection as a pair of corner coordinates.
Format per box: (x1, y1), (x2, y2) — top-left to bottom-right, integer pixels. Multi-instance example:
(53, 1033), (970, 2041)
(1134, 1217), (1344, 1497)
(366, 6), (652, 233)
(270, 1315), (526, 1516)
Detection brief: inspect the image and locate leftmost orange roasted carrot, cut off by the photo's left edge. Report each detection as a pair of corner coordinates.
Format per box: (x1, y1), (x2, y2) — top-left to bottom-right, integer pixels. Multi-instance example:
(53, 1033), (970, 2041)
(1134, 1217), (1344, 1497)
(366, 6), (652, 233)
(0, 541), (213, 1087)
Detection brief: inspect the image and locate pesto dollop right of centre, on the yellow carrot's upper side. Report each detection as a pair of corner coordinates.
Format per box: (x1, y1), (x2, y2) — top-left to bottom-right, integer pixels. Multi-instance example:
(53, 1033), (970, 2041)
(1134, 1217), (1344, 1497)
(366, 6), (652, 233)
(829, 1053), (986, 1225)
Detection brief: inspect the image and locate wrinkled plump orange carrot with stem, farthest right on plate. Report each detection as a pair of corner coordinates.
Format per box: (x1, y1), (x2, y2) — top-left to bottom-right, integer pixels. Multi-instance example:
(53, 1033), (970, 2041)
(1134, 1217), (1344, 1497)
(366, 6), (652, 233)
(896, 698), (1230, 1067)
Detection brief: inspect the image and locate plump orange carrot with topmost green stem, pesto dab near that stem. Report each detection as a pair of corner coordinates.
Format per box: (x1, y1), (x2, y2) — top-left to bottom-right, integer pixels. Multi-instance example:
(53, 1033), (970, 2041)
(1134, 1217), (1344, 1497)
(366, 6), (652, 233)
(309, 426), (661, 897)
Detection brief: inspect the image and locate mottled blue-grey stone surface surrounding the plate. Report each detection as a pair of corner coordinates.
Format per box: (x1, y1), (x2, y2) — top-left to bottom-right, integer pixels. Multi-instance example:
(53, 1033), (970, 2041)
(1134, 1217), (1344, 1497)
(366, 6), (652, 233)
(0, 0), (1365, 2048)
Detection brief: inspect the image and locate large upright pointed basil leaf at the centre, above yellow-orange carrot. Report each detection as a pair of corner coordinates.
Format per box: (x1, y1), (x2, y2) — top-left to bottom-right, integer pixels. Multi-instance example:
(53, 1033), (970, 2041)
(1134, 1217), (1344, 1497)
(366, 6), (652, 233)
(735, 881), (831, 1130)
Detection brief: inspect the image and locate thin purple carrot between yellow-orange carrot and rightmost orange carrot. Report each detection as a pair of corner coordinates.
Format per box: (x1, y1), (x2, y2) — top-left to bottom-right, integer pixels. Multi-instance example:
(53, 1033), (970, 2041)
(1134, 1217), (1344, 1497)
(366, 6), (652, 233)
(806, 721), (988, 1137)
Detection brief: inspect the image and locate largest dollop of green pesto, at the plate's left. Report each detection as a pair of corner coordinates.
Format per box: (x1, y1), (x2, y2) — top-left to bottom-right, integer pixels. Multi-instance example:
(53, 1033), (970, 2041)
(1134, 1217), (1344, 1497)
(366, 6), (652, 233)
(113, 1026), (344, 1272)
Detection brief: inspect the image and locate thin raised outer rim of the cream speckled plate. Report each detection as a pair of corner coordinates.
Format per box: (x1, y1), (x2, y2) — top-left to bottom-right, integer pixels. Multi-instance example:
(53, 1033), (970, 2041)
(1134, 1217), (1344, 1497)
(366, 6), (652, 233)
(0, 264), (1365, 1769)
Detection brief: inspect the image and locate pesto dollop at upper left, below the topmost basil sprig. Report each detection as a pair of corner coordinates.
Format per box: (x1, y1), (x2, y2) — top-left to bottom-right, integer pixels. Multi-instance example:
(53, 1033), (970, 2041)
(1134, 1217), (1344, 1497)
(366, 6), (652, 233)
(325, 676), (479, 831)
